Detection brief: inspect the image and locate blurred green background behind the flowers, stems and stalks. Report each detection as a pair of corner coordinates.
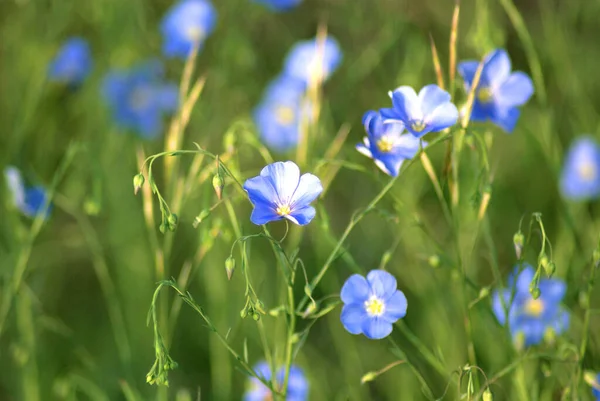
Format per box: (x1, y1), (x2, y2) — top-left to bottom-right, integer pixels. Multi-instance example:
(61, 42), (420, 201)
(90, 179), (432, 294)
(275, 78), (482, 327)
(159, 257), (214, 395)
(0, 0), (600, 401)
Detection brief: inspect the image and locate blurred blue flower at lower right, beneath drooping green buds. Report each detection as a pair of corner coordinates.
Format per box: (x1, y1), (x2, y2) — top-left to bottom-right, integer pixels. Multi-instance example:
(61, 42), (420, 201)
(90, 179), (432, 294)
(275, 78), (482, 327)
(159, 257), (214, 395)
(492, 265), (569, 346)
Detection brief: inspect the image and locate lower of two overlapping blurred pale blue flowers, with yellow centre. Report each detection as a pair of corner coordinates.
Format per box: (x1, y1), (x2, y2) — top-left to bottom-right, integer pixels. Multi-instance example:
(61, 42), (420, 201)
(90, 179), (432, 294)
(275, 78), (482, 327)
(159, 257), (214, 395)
(254, 76), (310, 152)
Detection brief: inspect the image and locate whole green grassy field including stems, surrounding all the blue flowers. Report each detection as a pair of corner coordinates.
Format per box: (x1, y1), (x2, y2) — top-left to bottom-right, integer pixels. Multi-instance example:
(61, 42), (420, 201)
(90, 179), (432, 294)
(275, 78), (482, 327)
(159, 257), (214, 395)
(0, 0), (600, 401)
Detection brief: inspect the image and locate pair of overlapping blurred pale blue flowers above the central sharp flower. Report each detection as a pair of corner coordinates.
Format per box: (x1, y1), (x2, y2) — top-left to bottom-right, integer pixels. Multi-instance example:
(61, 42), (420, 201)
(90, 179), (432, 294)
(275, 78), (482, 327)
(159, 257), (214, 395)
(254, 37), (342, 152)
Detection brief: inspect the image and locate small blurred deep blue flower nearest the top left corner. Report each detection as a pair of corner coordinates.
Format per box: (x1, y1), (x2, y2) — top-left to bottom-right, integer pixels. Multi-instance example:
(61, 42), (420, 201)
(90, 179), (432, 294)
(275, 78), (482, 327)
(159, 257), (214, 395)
(48, 37), (92, 86)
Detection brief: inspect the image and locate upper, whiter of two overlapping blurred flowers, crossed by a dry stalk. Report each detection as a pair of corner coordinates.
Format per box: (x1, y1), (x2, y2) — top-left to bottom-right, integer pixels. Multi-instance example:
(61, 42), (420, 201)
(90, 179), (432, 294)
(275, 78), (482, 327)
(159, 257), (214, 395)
(283, 36), (342, 85)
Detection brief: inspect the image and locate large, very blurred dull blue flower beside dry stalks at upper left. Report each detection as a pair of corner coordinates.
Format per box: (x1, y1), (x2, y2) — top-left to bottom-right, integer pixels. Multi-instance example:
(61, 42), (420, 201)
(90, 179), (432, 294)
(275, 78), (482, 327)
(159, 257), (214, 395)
(103, 61), (179, 138)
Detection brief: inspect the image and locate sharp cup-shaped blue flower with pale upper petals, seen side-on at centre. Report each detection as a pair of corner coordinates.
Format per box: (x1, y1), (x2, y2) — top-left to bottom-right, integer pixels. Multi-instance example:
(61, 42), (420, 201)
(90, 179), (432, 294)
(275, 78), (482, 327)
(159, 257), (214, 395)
(244, 161), (323, 226)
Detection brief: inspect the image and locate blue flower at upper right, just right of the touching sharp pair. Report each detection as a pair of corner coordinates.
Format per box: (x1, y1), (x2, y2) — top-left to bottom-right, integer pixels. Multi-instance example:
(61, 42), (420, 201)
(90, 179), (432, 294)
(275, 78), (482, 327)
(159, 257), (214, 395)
(458, 49), (533, 133)
